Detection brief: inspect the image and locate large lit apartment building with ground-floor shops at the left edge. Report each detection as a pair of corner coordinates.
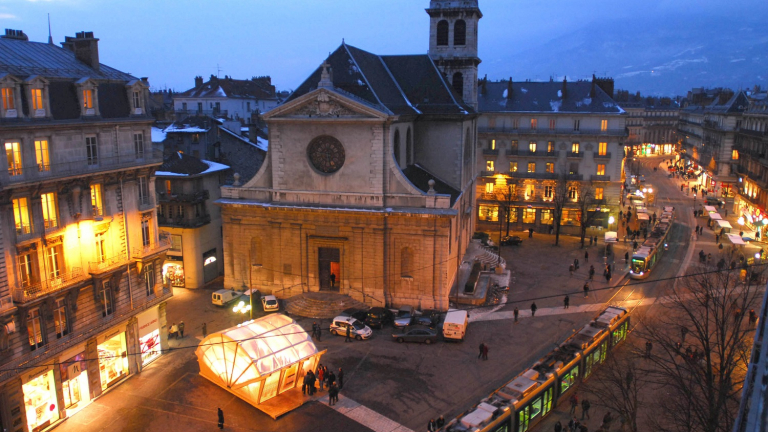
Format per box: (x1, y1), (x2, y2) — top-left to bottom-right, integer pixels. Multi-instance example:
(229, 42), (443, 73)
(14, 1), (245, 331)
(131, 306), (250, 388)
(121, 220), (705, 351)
(0, 30), (172, 431)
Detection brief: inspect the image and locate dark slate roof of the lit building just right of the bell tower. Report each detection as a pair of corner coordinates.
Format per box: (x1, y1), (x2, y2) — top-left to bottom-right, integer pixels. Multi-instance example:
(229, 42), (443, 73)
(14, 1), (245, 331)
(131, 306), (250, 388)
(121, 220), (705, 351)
(477, 81), (624, 114)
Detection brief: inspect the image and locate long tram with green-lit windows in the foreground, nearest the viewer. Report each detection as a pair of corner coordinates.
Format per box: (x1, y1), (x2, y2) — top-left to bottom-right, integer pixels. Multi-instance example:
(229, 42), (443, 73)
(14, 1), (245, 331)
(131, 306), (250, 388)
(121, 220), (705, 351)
(441, 306), (630, 432)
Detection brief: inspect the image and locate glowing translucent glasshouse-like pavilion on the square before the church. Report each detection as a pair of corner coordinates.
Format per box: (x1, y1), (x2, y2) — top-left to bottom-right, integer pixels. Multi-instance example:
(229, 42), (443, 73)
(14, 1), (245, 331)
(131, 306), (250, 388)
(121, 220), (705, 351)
(195, 314), (326, 419)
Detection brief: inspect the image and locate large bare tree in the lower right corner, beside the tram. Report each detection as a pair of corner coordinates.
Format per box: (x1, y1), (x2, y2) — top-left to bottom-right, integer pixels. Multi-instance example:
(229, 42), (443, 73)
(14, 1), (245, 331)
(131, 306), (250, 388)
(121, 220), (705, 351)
(643, 250), (763, 432)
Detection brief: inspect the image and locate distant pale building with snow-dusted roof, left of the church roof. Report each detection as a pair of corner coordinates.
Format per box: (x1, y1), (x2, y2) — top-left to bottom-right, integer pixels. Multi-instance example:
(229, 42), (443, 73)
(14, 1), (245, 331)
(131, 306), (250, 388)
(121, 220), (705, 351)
(173, 75), (278, 124)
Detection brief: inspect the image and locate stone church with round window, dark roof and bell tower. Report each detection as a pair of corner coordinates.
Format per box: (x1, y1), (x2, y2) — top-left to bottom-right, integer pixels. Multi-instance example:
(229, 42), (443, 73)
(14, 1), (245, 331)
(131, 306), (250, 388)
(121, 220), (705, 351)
(218, 0), (482, 310)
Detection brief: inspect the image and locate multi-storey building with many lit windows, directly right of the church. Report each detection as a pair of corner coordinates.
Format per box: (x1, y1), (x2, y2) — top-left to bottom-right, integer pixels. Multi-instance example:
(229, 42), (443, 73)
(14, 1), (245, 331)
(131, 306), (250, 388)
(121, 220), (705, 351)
(475, 79), (627, 234)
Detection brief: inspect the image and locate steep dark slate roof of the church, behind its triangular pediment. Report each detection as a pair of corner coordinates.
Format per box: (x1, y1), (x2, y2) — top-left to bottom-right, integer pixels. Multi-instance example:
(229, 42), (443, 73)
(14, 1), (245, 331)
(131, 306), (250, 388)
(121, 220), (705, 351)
(286, 43), (474, 115)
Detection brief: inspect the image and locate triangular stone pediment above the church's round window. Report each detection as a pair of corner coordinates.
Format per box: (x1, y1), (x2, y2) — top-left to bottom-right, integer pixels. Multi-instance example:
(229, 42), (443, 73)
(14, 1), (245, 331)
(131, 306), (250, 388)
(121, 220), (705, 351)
(264, 88), (387, 120)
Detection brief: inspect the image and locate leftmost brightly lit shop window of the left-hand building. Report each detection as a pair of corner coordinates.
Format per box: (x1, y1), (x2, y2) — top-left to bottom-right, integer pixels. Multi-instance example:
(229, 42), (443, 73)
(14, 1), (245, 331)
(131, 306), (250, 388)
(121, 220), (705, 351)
(21, 369), (59, 431)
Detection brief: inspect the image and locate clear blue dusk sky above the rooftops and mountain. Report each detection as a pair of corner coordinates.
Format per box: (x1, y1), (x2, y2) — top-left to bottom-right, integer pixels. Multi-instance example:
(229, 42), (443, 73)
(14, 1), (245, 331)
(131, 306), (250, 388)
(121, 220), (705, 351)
(0, 0), (768, 91)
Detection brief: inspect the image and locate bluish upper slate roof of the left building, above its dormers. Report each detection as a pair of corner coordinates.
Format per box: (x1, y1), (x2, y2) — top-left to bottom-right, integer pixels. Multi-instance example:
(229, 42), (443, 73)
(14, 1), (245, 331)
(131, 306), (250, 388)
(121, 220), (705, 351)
(0, 38), (137, 81)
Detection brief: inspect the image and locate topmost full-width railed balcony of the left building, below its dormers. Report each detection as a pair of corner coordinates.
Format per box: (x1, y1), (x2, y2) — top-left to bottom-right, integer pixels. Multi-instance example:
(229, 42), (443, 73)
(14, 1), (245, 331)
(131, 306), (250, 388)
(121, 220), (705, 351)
(0, 150), (163, 185)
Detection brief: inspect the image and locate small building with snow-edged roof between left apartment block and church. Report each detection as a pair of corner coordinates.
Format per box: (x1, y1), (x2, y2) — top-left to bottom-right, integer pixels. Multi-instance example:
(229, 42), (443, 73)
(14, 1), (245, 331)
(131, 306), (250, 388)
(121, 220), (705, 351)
(155, 152), (229, 288)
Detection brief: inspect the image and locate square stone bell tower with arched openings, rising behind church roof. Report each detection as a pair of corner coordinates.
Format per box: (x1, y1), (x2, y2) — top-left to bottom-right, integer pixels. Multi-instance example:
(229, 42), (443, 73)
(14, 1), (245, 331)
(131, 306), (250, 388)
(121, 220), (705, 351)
(427, 0), (483, 109)
